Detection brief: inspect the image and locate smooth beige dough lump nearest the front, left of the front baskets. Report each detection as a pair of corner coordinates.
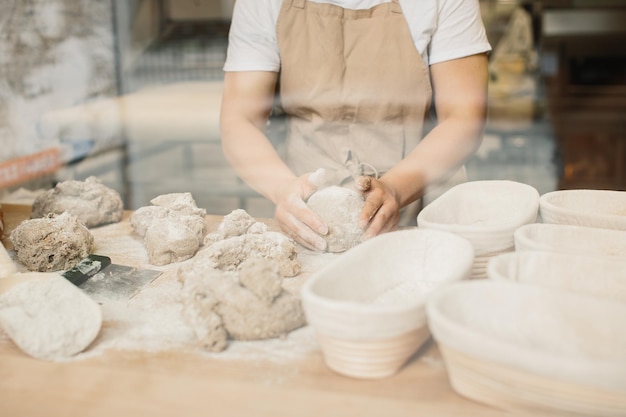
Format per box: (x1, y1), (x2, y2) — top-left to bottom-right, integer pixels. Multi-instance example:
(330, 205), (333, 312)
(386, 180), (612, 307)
(178, 257), (305, 352)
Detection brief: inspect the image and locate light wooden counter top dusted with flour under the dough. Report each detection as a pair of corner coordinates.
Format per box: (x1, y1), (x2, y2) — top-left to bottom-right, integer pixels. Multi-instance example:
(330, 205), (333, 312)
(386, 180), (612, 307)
(0, 205), (536, 417)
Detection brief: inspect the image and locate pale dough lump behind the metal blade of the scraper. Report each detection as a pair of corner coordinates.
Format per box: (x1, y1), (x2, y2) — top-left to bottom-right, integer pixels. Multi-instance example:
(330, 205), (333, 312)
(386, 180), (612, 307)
(130, 193), (206, 265)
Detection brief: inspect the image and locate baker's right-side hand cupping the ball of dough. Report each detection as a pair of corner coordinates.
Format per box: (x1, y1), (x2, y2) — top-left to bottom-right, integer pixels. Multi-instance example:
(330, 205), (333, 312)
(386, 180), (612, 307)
(356, 176), (400, 240)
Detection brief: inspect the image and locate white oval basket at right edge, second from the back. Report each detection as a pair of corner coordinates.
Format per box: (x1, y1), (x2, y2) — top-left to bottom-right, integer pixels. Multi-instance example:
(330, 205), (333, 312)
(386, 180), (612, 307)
(513, 223), (626, 259)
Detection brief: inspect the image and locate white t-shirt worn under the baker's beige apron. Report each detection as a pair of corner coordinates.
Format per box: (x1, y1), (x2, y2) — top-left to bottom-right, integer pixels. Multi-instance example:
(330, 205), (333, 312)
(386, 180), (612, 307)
(224, 0), (491, 72)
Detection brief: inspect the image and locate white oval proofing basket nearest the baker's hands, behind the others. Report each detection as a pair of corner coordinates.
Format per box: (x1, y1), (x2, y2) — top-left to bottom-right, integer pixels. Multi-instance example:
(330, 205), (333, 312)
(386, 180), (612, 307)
(417, 180), (539, 278)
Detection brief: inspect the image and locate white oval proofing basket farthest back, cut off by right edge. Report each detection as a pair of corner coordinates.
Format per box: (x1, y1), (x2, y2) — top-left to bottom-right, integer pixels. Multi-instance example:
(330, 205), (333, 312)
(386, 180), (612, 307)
(539, 189), (626, 230)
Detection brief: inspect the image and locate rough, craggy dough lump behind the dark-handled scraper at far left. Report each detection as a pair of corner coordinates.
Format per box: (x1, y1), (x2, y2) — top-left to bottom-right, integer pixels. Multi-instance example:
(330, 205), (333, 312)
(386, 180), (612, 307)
(9, 213), (94, 272)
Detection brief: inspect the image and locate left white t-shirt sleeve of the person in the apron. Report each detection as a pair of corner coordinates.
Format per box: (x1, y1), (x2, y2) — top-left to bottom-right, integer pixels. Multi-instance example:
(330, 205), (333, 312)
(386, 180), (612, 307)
(224, 0), (281, 72)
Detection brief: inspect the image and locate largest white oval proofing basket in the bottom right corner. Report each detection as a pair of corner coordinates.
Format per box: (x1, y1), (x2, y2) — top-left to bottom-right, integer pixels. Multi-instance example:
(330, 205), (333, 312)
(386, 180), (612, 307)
(427, 280), (626, 417)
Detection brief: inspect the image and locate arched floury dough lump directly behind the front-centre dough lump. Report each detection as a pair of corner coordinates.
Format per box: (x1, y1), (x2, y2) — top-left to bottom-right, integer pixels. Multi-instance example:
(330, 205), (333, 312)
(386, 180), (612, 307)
(196, 231), (302, 277)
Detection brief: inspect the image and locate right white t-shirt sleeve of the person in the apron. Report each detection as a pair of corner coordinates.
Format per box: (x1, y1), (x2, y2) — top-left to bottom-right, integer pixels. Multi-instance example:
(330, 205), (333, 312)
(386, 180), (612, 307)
(428, 0), (491, 65)
